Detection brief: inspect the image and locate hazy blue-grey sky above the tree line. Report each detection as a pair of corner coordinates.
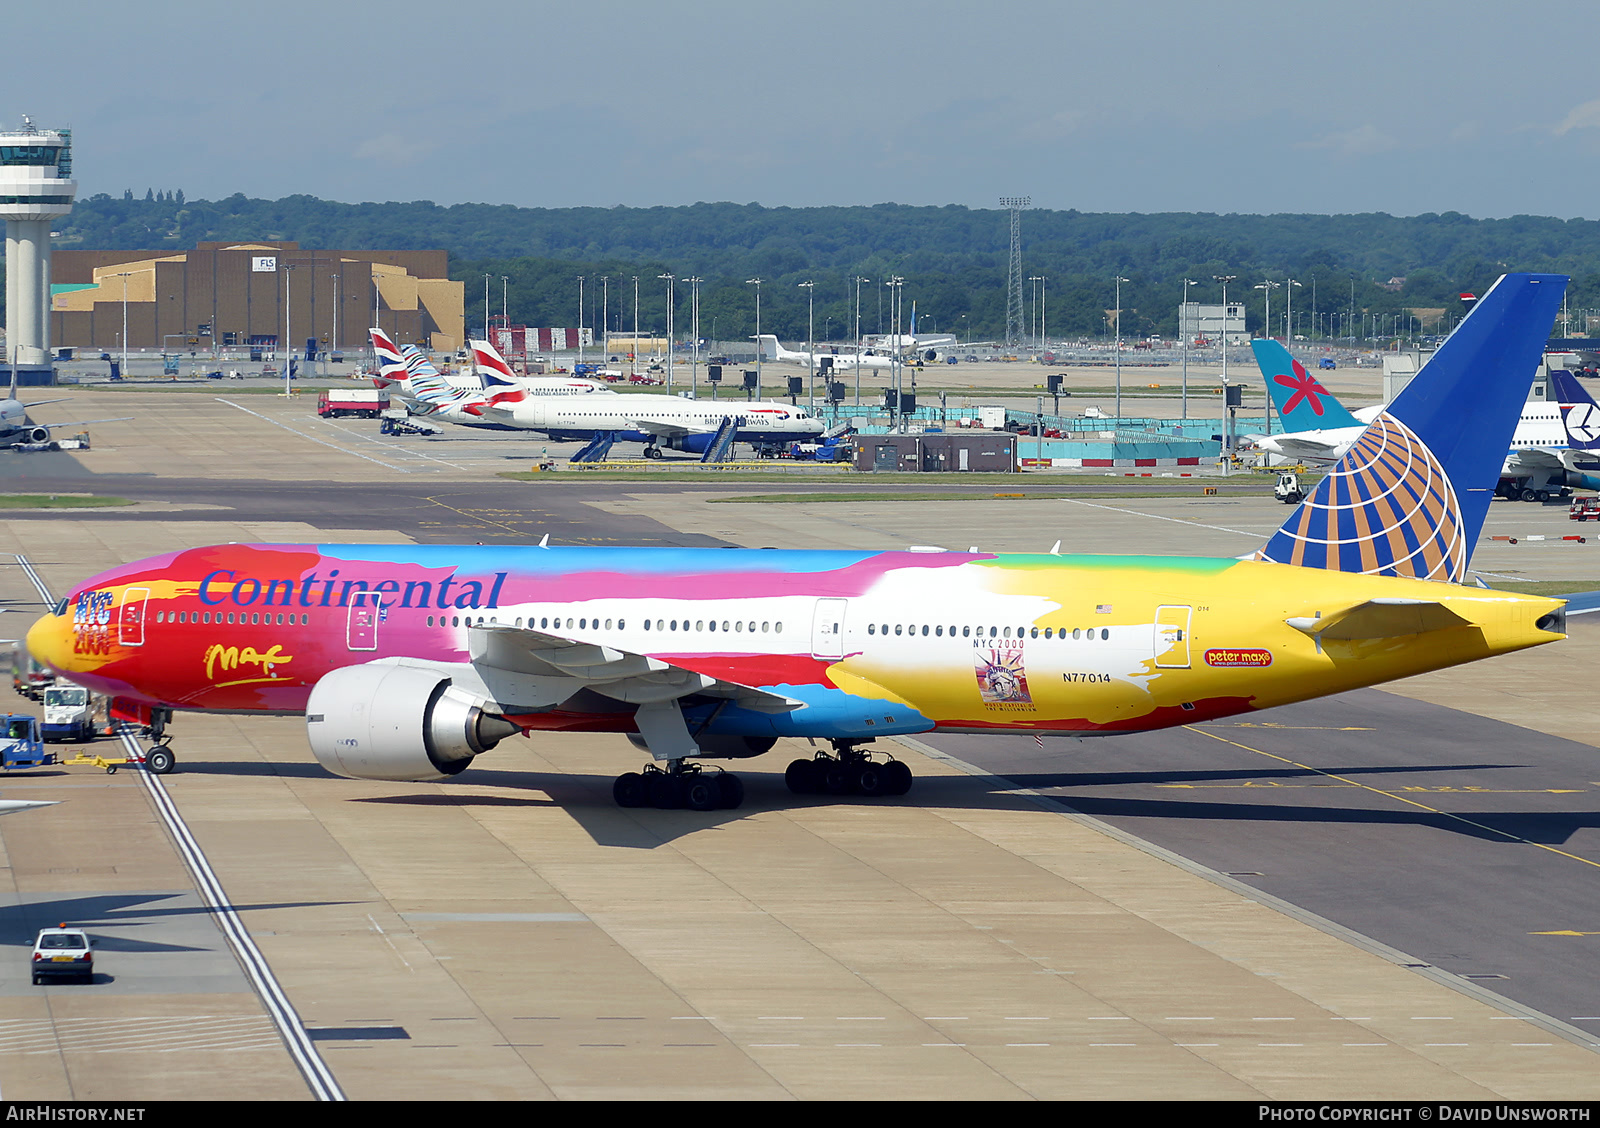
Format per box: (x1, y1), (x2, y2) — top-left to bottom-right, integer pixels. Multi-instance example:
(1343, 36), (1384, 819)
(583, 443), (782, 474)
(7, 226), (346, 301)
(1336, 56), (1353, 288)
(21, 0), (1600, 218)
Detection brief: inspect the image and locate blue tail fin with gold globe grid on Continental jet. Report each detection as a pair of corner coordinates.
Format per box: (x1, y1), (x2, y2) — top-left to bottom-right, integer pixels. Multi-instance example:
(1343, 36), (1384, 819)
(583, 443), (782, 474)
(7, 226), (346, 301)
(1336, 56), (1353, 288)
(1258, 274), (1566, 582)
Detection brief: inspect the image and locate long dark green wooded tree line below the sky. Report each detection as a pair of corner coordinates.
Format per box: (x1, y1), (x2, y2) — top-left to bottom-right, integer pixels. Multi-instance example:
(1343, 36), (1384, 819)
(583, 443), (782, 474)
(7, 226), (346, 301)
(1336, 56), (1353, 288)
(6, 190), (1600, 341)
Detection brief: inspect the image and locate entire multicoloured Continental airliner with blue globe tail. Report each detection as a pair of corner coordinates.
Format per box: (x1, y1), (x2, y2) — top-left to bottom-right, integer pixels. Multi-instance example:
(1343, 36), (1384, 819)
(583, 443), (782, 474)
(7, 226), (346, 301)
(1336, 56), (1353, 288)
(27, 274), (1566, 810)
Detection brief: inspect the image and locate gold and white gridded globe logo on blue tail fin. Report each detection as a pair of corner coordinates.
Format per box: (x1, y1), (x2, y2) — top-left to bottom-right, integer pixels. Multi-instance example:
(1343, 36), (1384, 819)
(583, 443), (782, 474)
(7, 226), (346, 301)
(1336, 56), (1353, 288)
(1258, 414), (1469, 582)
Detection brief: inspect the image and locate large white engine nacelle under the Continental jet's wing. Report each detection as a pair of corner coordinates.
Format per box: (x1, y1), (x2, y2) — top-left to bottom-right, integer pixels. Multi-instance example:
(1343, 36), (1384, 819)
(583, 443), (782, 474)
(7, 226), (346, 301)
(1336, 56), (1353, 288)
(306, 662), (522, 781)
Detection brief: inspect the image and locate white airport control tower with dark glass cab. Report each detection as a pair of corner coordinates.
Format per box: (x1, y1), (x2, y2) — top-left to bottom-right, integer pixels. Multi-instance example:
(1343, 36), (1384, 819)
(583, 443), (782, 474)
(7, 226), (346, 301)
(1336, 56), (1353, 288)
(0, 117), (78, 382)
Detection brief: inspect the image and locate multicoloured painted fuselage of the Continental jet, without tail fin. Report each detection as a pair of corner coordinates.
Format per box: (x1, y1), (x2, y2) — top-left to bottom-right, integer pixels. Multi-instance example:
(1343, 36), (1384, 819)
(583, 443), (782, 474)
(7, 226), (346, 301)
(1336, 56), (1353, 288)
(29, 544), (1558, 738)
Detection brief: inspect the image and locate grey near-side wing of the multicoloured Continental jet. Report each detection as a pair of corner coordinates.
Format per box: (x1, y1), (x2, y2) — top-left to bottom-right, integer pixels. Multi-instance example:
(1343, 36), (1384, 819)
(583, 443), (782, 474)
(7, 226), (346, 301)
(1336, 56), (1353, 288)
(469, 614), (805, 714)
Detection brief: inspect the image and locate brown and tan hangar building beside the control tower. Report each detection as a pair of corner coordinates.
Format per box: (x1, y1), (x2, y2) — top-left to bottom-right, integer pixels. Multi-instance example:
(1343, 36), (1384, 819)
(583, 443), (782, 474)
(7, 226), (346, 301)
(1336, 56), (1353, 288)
(50, 240), (466, 352)
